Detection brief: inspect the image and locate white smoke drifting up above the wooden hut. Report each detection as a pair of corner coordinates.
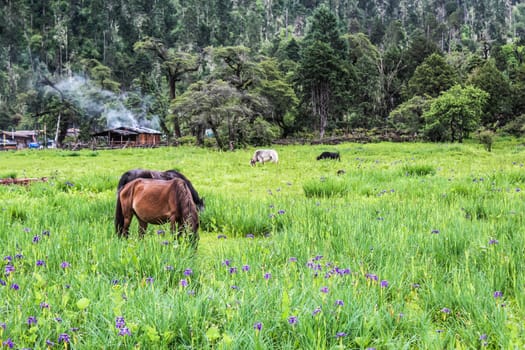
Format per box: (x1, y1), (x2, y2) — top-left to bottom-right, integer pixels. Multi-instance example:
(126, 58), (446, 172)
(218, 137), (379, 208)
(48, 75), (159, 130)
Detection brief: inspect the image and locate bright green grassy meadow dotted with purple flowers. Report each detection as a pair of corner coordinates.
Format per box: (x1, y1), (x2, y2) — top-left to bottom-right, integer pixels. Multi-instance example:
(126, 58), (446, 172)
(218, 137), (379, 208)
(0, 139), (525, 349)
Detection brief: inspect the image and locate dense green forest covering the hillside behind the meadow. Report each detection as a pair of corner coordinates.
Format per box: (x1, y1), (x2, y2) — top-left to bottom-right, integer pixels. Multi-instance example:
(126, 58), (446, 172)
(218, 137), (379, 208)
(0, 0), (525, 148)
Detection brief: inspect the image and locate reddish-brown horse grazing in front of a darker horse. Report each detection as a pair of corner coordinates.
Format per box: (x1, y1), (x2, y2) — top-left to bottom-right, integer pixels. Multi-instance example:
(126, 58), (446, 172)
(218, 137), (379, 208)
(115, 178), (199, 247)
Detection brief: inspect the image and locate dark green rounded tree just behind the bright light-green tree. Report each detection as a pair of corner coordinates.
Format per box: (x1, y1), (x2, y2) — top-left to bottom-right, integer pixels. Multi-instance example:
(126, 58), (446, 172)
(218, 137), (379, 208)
(406, 54), (457, 97)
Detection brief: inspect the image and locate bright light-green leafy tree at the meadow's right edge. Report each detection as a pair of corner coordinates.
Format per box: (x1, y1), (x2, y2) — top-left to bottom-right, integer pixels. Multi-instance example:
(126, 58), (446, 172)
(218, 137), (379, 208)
(423, 85), (489, 142)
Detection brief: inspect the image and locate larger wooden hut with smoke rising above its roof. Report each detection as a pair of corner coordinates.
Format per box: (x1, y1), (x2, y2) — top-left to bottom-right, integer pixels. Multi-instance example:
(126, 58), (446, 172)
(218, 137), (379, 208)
(91, 126), (162, 147)
